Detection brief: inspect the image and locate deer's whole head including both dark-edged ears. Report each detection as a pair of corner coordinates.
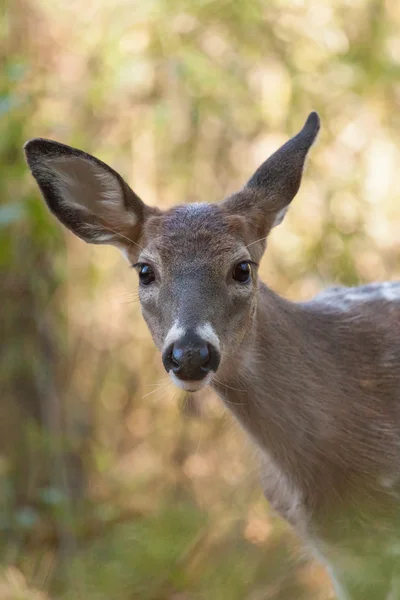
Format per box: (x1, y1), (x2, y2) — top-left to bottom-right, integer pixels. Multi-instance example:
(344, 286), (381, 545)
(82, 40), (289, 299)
(25, 113), (319, 391)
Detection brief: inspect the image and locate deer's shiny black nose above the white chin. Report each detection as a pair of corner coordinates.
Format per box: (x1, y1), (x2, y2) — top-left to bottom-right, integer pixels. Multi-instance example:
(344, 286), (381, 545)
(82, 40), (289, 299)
(163, 333), (220, 381)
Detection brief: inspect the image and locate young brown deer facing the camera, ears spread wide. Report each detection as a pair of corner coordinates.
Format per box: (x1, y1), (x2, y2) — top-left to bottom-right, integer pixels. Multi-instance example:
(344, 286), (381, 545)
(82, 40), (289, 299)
(24, 112), (400, 600)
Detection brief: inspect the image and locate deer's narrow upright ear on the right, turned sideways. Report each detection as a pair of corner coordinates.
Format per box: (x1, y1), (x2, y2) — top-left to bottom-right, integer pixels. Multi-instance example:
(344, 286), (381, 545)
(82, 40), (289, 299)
(222, 112), (320, 237)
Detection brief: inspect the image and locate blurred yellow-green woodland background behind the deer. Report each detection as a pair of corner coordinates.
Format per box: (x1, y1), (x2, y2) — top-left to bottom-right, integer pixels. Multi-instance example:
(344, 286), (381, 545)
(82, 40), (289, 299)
(0, 0), (400, 600)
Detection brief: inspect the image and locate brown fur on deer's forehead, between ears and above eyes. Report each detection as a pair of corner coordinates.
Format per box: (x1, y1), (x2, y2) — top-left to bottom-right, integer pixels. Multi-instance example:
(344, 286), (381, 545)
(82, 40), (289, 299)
(141, 203), (245, 260)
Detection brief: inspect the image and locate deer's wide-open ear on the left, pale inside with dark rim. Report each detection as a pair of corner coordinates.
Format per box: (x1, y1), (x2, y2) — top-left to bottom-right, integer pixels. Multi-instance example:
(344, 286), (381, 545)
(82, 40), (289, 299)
(24, 138), (155, 248)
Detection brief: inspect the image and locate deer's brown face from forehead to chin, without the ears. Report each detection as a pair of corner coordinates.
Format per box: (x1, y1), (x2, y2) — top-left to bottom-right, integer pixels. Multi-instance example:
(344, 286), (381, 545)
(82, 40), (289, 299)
(135, 204), (257, 390)
